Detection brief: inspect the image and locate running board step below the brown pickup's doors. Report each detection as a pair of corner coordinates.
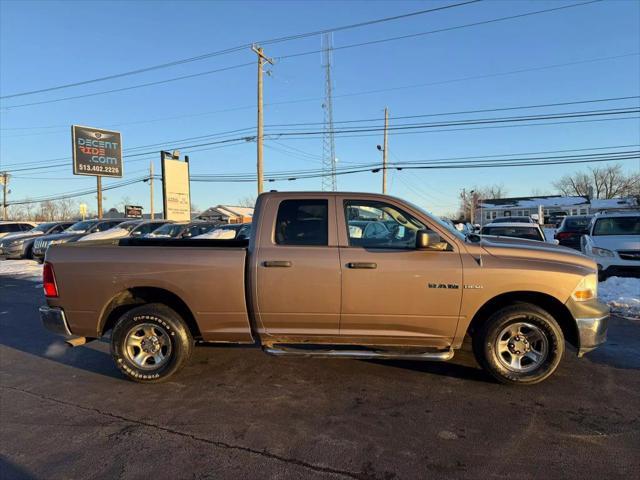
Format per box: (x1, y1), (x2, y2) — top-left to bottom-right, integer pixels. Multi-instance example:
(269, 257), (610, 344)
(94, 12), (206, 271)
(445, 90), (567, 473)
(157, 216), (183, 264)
(264, 345), (453, 362)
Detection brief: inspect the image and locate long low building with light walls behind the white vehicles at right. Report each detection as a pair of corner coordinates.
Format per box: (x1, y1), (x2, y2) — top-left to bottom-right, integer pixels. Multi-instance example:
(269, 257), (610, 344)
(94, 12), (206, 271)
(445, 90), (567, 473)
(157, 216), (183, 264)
(475, 195), (640, 224)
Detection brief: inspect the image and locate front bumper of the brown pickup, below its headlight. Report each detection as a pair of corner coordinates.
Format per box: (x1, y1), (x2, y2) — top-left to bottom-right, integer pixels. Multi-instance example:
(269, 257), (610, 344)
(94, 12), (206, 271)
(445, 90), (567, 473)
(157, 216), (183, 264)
(566, 299), (609, 357)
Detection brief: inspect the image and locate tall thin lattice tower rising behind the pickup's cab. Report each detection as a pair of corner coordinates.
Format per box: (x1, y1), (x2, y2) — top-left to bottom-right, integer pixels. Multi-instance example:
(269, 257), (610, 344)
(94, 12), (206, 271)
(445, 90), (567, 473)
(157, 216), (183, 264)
(322, 33), (337, 192)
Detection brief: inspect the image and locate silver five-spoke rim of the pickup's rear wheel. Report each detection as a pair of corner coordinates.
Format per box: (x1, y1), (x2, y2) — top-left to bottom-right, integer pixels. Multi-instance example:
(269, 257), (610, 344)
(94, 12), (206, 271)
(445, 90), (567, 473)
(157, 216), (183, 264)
(124, 323), (171, 370)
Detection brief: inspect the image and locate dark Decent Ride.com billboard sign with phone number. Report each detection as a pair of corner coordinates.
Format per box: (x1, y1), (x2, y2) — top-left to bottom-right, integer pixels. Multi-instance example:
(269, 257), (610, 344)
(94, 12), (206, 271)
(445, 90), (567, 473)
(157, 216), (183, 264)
(71, 125), (122, 177)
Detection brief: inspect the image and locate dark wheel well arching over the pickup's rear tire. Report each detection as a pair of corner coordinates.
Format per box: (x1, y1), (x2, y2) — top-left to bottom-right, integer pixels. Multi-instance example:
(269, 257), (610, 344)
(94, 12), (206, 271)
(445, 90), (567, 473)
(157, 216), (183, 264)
(100, 287), (202, 340)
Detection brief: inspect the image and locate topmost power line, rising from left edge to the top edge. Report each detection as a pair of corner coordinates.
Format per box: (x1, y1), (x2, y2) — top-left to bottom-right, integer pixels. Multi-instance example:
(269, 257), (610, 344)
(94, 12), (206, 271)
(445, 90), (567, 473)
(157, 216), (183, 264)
(0, 0), (481, 99)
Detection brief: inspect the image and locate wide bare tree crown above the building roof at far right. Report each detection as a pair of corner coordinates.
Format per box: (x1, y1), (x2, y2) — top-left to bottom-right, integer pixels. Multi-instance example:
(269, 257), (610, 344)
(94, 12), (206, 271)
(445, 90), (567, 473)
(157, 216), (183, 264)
(553, 164), (640, 199)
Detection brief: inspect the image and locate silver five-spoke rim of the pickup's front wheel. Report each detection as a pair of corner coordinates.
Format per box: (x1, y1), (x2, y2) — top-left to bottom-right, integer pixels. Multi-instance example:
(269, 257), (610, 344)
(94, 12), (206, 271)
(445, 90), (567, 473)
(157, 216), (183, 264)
(495, 322), (549, 373)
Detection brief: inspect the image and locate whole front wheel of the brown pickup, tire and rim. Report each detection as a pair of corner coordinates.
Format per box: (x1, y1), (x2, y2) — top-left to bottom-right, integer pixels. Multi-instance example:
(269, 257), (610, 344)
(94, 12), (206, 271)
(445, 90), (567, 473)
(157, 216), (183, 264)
(473, 303), (564, 385)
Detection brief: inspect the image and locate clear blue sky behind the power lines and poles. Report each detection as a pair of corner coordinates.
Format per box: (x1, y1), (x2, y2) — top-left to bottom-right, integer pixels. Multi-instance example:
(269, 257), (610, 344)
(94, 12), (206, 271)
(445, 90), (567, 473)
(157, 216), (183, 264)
(0, 0), (640, 214)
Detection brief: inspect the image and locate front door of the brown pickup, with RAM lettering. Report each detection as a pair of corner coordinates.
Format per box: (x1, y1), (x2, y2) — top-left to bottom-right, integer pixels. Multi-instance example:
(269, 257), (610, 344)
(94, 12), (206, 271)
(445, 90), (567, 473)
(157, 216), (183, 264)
(336, 197), (463, 347)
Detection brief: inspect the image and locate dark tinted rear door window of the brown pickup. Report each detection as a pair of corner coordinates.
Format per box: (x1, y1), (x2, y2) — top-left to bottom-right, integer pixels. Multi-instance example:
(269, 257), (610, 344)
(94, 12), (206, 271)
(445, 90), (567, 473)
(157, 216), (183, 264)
(275, 200), (329, 245)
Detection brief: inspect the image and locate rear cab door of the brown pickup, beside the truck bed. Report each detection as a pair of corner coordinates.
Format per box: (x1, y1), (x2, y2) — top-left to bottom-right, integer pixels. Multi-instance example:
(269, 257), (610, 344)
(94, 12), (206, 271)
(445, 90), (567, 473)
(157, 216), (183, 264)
(252, 195), (341, 337)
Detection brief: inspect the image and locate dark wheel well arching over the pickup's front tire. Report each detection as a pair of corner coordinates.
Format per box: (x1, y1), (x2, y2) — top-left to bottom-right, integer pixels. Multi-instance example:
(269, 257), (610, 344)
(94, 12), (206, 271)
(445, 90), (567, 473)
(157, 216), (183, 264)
(467, 292), (579, 348)
